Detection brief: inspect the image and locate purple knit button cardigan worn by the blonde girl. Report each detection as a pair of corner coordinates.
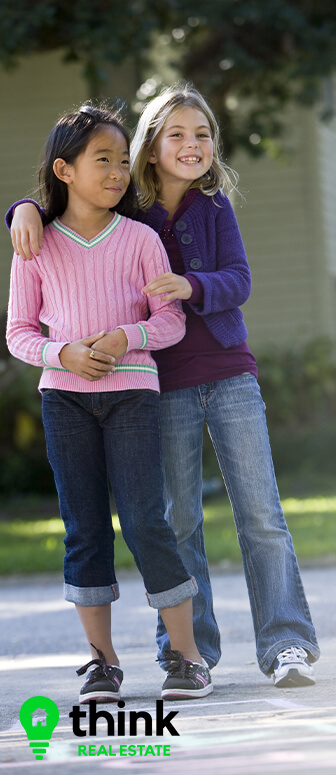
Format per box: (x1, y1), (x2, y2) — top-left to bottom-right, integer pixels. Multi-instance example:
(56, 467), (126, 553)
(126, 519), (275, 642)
(138, 191), (251, 347)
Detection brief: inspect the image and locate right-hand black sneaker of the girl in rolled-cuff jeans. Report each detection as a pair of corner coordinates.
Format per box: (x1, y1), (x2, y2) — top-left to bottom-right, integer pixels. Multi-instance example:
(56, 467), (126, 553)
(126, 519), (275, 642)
(161, 649), (213, 700)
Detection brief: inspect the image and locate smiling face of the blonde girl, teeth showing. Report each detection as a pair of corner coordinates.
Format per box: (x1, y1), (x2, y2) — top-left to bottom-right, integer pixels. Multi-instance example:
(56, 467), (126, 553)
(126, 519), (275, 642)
(149, 108), (213, 193)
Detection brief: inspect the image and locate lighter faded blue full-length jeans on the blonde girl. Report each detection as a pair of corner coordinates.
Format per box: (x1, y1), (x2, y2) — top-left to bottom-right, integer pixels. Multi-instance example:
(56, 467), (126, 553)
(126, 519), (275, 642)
(157, 374), (319, 674)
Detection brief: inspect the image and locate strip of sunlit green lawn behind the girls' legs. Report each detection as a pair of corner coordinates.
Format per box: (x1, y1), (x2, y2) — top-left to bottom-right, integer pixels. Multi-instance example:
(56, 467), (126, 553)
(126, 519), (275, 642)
(0, 484), (336, 575)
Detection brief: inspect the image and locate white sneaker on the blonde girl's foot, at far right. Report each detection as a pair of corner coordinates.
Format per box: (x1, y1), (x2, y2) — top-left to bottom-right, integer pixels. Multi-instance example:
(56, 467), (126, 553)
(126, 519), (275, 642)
(272, 646), (315, 689)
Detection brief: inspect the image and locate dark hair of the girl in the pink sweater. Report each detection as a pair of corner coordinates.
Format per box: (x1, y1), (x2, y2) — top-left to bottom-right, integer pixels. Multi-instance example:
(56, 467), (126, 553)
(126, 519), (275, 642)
(39, 103), (136, 223)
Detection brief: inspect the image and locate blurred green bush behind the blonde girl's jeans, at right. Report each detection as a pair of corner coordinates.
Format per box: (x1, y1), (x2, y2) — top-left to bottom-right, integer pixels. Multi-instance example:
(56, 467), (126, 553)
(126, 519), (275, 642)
(203, 339), (336, 493)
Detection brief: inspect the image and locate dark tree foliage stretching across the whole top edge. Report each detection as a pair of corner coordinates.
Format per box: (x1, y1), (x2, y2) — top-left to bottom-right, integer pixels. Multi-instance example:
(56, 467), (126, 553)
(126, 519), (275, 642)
(0, 0), (336, 155)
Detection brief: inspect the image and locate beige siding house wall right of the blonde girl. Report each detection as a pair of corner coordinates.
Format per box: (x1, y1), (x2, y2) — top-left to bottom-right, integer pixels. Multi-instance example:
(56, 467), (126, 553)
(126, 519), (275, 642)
(232, 104), (331, 351)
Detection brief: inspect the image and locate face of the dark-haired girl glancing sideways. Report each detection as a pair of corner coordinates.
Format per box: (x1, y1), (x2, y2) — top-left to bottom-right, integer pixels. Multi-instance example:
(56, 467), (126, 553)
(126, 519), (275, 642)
(56, 125), (130, 211)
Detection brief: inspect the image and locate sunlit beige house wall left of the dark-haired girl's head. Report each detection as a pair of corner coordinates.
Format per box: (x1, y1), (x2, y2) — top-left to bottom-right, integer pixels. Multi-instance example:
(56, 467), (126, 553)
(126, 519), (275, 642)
(0, 52), (87, 313)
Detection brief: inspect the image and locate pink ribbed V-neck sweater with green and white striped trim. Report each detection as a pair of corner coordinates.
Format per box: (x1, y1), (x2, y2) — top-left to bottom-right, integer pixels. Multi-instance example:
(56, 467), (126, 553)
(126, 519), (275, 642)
(7, 214), (185, 393)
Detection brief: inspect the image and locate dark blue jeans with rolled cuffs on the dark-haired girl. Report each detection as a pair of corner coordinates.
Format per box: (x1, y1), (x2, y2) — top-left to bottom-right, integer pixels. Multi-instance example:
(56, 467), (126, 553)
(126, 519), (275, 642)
(42, 390), (197, 608)
